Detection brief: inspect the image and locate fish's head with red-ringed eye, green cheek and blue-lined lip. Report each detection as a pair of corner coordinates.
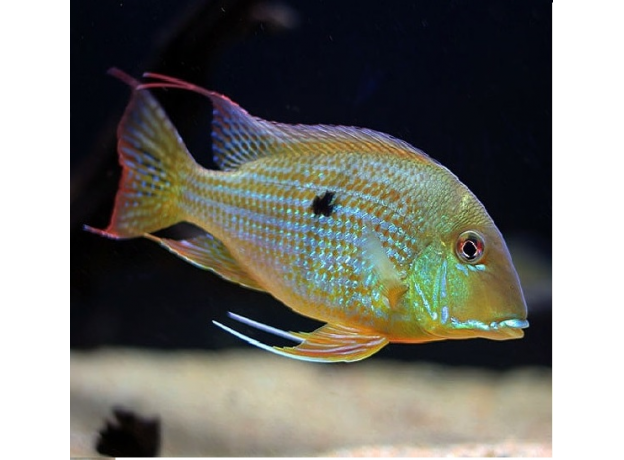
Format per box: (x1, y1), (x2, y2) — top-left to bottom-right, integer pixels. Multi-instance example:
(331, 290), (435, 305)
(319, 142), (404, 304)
(408, 192), (529, 340)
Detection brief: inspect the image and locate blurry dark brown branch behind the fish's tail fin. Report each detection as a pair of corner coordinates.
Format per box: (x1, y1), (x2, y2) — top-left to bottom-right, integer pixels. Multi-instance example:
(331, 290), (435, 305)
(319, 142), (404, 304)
(71, 0), (266, 231)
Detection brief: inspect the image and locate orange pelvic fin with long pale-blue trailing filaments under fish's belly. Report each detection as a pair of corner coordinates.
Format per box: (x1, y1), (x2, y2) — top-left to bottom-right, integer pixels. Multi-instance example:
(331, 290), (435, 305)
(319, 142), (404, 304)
(213, 313), (388, 363)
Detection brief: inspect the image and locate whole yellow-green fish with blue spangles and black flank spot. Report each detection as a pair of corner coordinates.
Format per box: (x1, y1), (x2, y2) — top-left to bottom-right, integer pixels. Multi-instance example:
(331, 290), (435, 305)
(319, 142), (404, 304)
(87, 69), (528, 362)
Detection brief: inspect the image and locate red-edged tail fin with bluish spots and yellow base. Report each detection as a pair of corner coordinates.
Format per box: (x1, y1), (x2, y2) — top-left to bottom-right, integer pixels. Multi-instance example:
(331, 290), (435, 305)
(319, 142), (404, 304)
(86, 69), (196, 238)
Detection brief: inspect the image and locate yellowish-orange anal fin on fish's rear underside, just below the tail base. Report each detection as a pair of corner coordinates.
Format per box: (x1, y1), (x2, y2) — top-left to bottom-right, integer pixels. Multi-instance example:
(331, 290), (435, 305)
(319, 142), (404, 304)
(145, 233), (264, 291)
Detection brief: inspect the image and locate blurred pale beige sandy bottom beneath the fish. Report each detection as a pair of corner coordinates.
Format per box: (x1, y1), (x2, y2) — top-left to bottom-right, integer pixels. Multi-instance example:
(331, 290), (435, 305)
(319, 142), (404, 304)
(70, 350), (552, 457)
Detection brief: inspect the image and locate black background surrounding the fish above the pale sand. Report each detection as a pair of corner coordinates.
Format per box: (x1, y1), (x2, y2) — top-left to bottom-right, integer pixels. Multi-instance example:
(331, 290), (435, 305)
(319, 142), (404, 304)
(71, 0), (552, 368)
